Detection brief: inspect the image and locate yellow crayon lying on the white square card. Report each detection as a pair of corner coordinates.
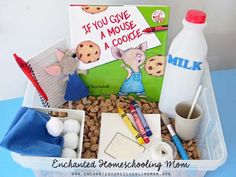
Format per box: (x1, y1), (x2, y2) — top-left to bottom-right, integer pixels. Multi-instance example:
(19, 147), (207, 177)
(118, 107), (144, 144)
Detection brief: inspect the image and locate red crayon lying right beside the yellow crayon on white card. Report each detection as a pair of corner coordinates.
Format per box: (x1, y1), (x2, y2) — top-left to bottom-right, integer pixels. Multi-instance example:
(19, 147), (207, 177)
(130, 104), (150, 144)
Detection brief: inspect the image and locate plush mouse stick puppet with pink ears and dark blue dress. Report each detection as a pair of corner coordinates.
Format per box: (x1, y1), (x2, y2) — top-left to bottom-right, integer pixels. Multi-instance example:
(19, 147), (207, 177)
(45, 49), (89, 109)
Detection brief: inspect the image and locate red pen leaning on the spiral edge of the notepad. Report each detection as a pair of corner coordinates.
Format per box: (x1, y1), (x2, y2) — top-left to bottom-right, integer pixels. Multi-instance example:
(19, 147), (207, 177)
(13, 53), (48, 101)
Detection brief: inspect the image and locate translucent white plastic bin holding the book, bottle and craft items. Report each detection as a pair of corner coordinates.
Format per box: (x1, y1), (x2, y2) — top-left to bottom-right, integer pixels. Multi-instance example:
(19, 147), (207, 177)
(12, 63), (227, 177)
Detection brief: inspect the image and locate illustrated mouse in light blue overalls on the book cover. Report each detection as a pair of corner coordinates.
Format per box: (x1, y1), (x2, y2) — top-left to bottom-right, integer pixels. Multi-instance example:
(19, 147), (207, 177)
(111, 42), (147, 97)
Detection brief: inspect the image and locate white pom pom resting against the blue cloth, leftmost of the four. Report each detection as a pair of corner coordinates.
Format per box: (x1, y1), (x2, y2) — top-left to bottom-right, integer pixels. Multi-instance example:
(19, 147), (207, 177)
(46, 117), (63, 137)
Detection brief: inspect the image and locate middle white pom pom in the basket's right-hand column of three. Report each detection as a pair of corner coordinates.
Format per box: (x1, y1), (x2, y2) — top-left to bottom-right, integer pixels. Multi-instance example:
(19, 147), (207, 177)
(64, 132), (79, 149)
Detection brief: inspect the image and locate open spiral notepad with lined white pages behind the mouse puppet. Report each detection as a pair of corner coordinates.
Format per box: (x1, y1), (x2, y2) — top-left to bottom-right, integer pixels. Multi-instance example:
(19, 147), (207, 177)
(27, 40), (68, 107)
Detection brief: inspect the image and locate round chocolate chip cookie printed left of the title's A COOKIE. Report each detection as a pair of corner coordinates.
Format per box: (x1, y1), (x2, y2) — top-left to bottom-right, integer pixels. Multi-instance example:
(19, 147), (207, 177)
(76, 41), (101, 64)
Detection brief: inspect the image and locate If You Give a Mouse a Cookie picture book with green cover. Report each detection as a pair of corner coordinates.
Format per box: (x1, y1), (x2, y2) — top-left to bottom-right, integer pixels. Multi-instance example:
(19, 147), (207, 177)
(69, 5), (169, 101)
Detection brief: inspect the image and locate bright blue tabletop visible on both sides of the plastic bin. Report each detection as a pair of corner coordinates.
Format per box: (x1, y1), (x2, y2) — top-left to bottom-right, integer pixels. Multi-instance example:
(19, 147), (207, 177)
(0, 70), (236, 177)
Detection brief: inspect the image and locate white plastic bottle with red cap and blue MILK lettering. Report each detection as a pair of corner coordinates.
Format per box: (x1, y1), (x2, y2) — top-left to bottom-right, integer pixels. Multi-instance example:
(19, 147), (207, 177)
(159, 10), (207, 118)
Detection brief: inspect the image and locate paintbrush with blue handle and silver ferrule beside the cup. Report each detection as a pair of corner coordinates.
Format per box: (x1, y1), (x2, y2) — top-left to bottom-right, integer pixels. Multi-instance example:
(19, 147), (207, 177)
(161, 114), (189, 160)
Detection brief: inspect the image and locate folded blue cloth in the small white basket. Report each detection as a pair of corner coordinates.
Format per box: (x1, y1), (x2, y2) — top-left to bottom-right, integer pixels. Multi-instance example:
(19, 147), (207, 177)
(0, 107), (64, 157)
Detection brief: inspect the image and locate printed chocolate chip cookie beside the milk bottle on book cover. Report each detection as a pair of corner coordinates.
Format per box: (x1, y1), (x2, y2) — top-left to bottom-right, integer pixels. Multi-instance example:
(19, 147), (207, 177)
(145, 55), (165, 77)
